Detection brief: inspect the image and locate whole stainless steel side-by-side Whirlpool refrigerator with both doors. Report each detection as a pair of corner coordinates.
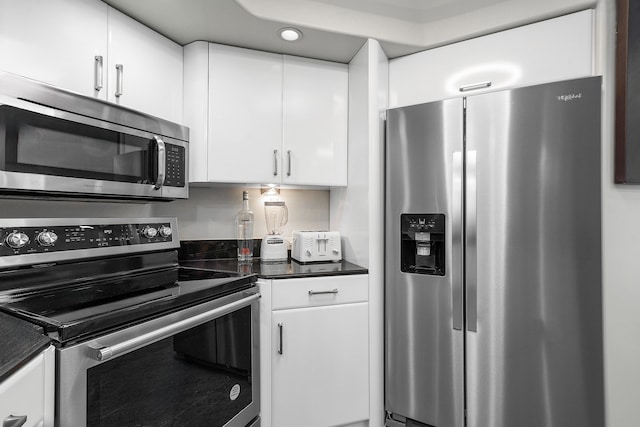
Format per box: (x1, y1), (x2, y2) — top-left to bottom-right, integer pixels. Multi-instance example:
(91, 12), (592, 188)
(385, 77), (605, 427)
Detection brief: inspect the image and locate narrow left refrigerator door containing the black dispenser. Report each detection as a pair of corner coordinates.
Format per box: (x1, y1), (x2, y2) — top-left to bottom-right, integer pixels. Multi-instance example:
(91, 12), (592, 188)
(385, 99), (464, 427)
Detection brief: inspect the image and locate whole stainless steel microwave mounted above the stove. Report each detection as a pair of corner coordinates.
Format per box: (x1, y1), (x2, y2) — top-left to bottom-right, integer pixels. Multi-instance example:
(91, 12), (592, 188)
(0, 72), (189, 200)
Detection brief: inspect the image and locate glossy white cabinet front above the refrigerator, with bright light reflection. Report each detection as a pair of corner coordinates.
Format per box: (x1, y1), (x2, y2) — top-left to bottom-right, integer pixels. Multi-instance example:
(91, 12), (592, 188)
(389, 10), (593, 108)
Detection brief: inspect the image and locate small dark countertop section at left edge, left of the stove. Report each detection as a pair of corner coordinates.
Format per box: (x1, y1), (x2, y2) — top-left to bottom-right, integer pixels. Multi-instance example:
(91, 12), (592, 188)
(0, 312), (50, 382)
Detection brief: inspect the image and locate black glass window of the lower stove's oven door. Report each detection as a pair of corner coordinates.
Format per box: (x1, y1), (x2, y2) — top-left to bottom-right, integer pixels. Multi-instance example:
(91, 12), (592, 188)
(87, 307), (252, 427)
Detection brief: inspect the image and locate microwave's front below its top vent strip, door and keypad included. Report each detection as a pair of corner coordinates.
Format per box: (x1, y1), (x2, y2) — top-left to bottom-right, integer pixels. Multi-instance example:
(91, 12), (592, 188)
(0, 100), (188, 199)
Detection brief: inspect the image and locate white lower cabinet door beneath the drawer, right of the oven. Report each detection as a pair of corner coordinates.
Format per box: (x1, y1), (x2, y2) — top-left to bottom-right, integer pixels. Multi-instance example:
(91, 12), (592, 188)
(271, 303), (369, 427)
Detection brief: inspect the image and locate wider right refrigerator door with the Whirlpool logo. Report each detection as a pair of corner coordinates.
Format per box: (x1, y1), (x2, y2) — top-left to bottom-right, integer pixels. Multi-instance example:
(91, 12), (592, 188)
(465, 77), (605, 427)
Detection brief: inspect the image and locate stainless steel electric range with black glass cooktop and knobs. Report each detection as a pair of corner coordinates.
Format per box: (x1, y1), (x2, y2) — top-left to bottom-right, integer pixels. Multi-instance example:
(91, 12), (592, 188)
(0, 218), (260, 427)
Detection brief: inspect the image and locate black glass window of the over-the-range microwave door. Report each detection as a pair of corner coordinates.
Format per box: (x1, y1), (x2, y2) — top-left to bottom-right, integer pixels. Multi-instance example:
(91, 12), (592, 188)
(0, 105), (154, 184)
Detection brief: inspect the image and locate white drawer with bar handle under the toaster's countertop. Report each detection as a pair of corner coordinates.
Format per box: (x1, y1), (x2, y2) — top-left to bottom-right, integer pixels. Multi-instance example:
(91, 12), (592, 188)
(271, 274), (369, 310)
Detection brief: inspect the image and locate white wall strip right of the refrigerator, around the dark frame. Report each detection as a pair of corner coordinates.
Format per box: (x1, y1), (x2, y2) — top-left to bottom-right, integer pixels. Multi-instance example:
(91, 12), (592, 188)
(596, 0), (640, 427)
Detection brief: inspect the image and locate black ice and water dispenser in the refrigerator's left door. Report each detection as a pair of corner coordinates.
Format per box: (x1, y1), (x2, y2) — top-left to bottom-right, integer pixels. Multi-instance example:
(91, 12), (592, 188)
(400, 214), (445, 276)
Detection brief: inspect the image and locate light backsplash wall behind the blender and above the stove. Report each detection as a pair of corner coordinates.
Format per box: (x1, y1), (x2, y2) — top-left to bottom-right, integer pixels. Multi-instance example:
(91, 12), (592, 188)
(0, 187), (329, 241)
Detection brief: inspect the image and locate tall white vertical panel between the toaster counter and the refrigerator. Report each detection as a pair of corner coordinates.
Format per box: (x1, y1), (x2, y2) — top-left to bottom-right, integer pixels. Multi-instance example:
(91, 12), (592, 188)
(330, 40), (389, 427)
